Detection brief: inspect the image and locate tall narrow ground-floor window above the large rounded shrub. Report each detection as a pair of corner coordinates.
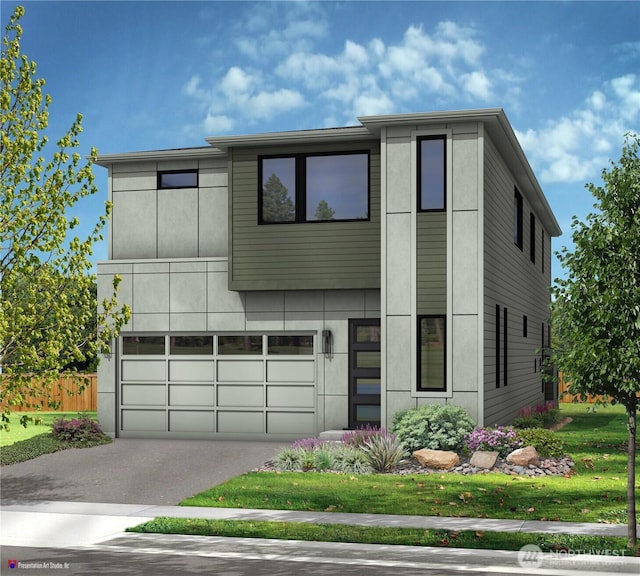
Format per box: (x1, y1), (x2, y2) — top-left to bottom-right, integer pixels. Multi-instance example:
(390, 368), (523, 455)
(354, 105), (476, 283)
(418, 316), (447, 391)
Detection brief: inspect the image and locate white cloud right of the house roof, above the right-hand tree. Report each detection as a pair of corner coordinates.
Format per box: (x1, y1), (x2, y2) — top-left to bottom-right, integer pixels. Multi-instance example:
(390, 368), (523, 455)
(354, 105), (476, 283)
(518, 74), (640, 182)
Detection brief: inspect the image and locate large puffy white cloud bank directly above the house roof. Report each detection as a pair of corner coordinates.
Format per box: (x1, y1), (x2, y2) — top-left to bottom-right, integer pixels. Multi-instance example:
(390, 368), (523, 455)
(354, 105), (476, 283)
(184, 16), (523, 134)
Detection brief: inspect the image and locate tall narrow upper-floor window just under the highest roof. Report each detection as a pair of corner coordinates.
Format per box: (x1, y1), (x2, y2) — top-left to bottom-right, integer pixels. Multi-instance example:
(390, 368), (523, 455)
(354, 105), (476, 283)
(418, 136), (447, 211)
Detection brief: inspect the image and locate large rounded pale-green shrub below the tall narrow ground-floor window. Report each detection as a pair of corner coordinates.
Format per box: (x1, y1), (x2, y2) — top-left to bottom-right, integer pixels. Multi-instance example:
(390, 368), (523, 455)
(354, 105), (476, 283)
(391, 404), (475, 453)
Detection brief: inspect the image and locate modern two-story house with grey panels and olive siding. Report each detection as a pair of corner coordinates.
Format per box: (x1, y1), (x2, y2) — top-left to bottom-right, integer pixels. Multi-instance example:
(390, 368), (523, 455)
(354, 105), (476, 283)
(98, 109), (560, 440)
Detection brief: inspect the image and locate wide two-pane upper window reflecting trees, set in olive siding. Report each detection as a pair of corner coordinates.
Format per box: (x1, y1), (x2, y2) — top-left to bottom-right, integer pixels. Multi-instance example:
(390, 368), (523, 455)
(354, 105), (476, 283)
(258, 152), (369, 224)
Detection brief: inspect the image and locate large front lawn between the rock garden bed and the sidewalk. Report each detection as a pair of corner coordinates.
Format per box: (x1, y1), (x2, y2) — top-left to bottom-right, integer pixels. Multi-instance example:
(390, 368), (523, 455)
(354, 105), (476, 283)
(175, 405), (627, 523)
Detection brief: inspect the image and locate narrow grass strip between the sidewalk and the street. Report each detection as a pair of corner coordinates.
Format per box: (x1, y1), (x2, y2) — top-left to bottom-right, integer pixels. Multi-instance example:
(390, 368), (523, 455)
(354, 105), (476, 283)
(127, 517), (630, 555)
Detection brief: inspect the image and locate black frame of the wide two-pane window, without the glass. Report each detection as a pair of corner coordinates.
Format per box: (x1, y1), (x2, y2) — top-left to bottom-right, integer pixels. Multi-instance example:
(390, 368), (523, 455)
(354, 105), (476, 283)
(258, 149), (371, 226)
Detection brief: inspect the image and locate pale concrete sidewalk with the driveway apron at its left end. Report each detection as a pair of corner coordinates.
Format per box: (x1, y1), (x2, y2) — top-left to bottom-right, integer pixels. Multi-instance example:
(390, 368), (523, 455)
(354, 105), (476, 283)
(0, 501), (627, 547)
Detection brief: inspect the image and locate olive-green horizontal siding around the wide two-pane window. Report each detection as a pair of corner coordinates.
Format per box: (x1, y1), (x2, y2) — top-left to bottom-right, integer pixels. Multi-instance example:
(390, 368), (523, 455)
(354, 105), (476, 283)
(229, 141), (380, 290)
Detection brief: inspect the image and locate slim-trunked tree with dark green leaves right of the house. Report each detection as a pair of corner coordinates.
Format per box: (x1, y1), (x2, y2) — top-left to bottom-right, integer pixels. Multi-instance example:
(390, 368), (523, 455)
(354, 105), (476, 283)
(553, 135), (640, 548)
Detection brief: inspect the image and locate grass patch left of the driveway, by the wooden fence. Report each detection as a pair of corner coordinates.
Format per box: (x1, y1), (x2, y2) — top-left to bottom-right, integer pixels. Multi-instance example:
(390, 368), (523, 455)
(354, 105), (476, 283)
(0, 412), (111, 466)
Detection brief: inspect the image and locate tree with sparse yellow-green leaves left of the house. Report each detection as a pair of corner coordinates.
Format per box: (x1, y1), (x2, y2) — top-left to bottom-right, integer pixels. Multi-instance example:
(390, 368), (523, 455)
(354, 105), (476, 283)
(0, 6), (129, 426)
